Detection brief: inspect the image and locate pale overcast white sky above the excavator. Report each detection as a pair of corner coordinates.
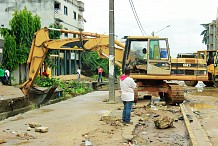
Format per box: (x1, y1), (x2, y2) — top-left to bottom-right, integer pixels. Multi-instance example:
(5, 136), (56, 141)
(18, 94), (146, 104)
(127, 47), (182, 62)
(82, 0), (218, 57)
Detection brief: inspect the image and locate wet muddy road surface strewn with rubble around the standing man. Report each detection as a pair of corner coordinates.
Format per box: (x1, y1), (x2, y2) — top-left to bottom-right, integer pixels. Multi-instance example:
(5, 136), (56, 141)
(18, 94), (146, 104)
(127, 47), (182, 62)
(0, 83), (218, 146)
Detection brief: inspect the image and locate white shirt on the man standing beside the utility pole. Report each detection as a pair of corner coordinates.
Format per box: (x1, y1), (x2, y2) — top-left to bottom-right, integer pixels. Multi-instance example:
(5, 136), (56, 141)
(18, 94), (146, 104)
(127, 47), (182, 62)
(120, 77), (136, 101)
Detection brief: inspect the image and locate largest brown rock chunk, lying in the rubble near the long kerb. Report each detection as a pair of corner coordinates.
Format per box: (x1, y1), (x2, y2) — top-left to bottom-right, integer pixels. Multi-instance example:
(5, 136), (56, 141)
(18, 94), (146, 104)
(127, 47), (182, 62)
(154, 116), (174, 129)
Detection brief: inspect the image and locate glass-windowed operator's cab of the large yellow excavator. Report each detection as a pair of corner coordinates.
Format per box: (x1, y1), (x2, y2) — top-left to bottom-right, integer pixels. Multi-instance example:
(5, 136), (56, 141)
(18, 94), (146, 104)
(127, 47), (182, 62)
(123, 36), (171, 75)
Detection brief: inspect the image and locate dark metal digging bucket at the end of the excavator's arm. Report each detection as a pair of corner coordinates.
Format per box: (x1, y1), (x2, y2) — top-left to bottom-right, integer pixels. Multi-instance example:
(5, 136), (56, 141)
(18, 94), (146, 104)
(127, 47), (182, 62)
(29, 85), (57, 106)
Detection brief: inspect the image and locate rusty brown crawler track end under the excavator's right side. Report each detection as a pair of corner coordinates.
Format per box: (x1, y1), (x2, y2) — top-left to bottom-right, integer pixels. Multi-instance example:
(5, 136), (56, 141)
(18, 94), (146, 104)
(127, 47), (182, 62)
(166, 83), (184, 104)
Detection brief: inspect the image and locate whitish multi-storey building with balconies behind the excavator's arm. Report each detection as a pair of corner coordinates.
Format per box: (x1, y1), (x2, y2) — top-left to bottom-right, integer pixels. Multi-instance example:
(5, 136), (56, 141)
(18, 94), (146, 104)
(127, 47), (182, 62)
(0, 0), (84, 82)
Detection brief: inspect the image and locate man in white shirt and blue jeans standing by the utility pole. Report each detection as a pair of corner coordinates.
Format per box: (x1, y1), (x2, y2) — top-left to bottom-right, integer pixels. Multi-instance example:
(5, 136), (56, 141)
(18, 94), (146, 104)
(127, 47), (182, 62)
(120, 67), (136, 124)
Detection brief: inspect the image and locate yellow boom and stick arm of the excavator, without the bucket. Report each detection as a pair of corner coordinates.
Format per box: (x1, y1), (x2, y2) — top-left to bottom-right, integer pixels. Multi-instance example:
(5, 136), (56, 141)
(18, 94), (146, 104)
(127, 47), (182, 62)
(20, 28), (125, 104)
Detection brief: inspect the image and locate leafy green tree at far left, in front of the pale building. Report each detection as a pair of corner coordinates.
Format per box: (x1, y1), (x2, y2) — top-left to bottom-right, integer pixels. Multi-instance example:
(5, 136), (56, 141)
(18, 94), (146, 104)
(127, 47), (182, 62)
(0, 7), (41, 71)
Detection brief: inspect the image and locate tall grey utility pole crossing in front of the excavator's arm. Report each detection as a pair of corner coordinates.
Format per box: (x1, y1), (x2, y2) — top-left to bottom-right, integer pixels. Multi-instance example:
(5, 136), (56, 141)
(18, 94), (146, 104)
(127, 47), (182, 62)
(109, 0), (115, 103)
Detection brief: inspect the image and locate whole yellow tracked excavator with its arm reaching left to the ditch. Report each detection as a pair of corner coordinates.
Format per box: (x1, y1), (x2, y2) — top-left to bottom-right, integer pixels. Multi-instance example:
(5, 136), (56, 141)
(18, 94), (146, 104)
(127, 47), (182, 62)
(20, 28), (208, 104)
